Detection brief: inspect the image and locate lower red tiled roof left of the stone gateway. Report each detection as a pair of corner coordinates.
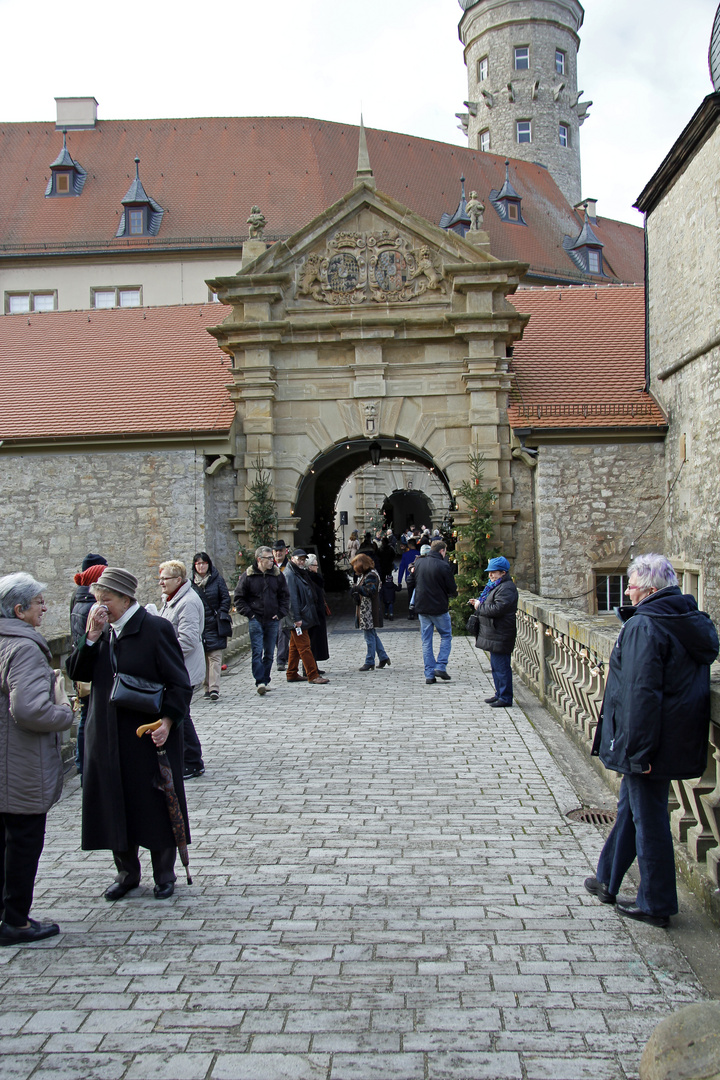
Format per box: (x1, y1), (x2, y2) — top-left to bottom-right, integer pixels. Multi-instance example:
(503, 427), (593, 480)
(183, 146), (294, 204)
(0, 303), (235, 440)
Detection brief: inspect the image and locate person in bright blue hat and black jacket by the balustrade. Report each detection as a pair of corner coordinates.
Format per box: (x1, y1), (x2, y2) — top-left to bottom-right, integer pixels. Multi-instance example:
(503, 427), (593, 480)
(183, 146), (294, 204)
(468, 555), (517, 708)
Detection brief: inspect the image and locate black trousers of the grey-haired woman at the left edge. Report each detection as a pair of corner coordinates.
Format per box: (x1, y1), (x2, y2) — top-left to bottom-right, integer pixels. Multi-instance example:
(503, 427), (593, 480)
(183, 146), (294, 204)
(0, 812), (46, 927)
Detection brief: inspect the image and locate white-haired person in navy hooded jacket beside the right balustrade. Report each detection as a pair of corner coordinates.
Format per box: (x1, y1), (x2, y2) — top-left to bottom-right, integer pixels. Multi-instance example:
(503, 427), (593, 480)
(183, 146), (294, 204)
(585, 555), (718, 927)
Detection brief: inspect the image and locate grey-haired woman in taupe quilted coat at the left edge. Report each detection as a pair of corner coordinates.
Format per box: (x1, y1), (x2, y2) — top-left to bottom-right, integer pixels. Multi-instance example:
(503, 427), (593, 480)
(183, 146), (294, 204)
(0, 573), (72, 945)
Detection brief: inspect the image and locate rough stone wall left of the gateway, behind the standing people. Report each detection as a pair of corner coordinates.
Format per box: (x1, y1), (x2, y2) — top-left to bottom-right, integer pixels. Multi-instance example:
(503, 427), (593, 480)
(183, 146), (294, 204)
(0, 449), (234, 636)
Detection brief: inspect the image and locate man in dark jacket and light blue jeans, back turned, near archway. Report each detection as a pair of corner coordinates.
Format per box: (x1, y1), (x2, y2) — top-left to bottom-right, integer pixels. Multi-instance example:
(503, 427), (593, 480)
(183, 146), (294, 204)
(412, 540), (458, 684)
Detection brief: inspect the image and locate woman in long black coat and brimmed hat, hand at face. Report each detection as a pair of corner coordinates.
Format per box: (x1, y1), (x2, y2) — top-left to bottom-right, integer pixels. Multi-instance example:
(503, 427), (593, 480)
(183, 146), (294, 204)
(67, 567), (192, 900)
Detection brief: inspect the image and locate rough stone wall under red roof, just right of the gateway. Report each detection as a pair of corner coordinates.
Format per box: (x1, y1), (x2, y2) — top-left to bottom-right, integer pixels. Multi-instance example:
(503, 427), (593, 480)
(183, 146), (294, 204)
(528, 443), (665, 610)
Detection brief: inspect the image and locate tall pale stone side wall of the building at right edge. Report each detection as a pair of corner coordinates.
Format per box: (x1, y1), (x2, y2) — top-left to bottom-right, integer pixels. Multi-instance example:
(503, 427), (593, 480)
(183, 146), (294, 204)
(647, 120), (720, 622)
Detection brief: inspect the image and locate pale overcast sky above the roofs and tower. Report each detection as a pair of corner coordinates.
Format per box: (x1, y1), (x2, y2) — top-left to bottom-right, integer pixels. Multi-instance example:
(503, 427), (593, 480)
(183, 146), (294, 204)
(0, 0), (717, 225)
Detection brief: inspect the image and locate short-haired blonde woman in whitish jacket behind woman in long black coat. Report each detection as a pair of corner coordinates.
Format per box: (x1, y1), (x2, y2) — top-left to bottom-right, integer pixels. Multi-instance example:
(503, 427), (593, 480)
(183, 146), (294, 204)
(158, 558), (205, 780)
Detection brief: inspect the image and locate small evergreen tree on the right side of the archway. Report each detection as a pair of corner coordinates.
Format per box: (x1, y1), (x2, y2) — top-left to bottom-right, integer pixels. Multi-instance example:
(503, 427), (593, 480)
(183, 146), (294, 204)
(450, 450), (499, 633)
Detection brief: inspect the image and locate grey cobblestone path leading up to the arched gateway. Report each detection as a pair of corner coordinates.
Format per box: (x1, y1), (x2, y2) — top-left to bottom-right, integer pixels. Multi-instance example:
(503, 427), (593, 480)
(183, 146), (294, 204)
(0, 622), (703, 1080)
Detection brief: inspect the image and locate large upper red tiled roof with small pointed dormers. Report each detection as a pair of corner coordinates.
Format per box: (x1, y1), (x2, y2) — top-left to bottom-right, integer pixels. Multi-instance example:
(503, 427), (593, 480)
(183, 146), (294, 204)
(0, 117), (644, 282)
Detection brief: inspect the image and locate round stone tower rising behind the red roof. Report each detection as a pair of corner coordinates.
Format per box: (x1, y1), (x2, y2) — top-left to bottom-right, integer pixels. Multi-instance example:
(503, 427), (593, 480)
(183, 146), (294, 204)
(458, 0), (593, 206)
